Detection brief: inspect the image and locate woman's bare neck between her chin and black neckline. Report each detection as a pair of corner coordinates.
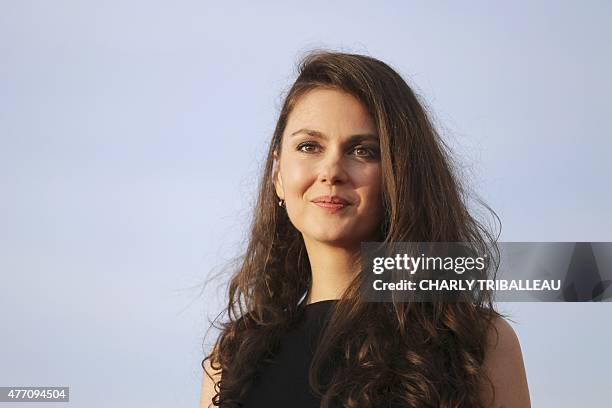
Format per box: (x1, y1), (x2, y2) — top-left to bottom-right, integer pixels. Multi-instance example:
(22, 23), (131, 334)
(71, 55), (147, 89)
(304, 237), (359, 304)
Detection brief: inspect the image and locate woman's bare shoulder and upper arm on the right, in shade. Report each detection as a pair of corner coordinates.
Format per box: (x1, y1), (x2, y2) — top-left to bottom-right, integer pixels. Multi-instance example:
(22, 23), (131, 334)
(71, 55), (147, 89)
(481, 318), (531, 408)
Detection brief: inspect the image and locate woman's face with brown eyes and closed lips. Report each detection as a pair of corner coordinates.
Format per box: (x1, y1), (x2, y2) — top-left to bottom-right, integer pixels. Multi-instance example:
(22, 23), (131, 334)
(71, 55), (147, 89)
(274, 88), (382, 247)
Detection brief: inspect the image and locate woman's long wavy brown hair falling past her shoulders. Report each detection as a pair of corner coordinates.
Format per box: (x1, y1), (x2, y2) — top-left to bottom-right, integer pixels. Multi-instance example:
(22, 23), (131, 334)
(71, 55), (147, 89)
(202, 51), (501, 408)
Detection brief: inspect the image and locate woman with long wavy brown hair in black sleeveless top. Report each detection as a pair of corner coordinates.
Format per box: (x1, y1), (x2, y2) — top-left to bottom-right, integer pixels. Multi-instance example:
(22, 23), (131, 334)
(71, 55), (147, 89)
(201, 52), (530, 408)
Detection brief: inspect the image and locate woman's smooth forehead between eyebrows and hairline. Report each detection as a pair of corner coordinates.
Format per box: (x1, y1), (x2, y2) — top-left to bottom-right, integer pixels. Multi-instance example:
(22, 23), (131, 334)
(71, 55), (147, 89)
(285, 88), (376, 135)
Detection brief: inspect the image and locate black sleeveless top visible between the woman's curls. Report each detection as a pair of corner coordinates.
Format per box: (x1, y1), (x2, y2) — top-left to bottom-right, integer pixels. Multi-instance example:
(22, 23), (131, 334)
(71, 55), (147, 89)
(241, 299), (337, 408)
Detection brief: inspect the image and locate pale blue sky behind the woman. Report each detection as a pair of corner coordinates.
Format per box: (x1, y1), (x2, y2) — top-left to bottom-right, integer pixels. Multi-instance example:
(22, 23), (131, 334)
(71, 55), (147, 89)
(0, 0), (612, 408)
